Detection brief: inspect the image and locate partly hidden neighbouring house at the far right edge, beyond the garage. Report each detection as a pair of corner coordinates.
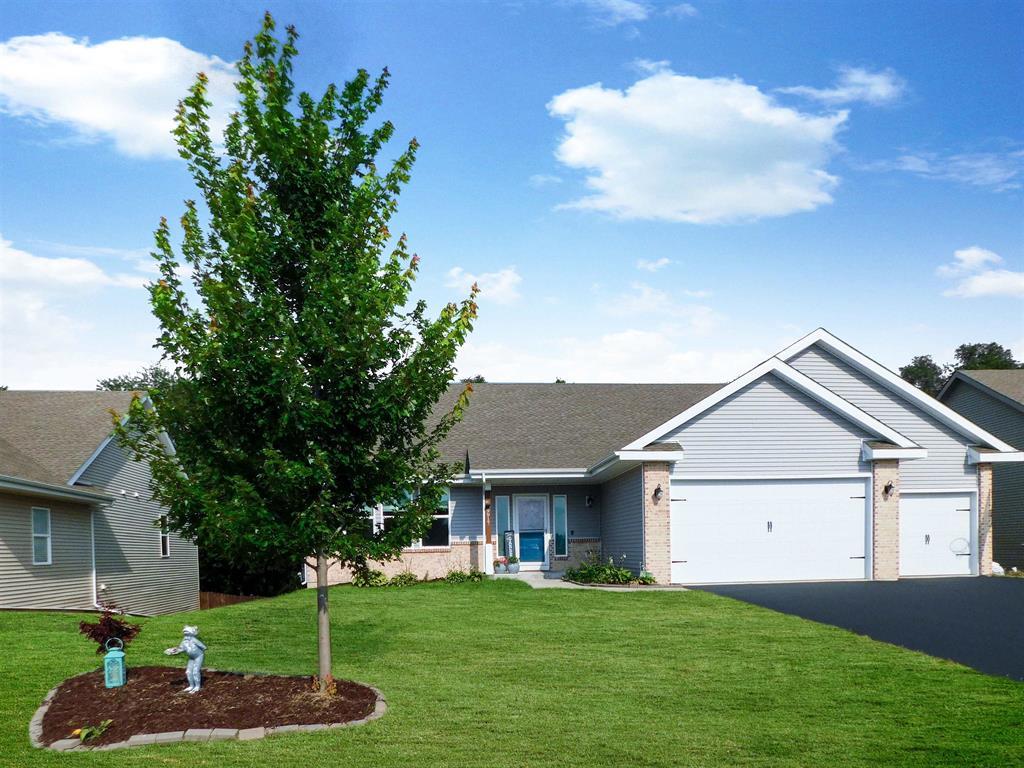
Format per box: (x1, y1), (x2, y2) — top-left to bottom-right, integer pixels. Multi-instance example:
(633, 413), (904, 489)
(939, 370), (1024, 568)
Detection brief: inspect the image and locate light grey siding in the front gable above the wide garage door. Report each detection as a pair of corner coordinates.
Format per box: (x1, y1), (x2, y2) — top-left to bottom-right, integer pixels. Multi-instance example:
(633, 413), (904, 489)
(662, 374), (870, 479)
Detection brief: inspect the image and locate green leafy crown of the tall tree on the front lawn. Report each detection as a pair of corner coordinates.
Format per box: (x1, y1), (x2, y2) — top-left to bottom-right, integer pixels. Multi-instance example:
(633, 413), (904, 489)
(112, 14), (477, 684)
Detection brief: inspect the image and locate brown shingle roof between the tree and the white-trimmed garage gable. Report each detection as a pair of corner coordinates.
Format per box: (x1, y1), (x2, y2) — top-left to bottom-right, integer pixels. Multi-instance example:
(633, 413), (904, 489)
(438, 384), (723, 470)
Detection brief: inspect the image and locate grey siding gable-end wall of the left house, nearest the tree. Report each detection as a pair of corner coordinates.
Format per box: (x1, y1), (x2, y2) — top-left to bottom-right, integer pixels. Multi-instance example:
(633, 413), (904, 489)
(79, 441), (199, 614)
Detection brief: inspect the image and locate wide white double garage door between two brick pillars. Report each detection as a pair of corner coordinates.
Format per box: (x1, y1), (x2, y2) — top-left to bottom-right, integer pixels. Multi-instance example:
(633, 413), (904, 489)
(672, 478), (869, 584)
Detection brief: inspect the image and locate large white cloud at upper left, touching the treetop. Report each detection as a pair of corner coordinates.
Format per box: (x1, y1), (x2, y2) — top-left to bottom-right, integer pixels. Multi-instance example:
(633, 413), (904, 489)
(0, 32), (238, 157)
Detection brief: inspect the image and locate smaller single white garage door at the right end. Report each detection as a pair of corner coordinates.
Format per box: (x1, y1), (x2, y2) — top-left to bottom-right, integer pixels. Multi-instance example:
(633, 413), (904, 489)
(899, 492), (976, 575)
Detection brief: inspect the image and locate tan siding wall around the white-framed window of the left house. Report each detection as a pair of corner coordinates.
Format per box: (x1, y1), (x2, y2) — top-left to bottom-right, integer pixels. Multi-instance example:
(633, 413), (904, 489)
(0, 494), (92, 610)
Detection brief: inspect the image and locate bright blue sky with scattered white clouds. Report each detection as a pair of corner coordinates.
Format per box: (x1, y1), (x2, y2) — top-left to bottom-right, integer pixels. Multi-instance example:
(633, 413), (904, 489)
(0, 0), (1024, 388)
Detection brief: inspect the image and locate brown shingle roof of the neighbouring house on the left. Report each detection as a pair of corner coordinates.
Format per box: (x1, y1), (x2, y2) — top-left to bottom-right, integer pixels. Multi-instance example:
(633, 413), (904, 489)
(0, 391), (138, 484)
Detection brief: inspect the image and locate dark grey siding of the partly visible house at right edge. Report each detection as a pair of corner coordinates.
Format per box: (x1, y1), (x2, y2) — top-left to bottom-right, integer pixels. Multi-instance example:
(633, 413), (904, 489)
(942, 381), (1024, 568)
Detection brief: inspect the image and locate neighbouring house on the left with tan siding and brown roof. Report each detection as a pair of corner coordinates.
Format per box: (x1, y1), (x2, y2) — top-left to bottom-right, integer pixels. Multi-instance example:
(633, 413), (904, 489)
(0, 391), (199, 614)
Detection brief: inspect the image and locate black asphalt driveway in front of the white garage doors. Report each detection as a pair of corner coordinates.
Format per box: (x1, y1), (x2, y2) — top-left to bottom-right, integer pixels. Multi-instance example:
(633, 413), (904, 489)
(695, 578), (1024, 680)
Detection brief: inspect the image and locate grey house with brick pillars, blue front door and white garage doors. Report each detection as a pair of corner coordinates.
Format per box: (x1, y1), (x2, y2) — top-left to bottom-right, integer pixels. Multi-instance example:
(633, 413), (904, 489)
(309, 329), (1024, 585)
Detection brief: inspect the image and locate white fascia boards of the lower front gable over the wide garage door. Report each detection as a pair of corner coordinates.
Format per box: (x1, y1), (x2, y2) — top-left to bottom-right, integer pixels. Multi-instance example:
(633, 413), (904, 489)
(623, 357), (918, 451)
